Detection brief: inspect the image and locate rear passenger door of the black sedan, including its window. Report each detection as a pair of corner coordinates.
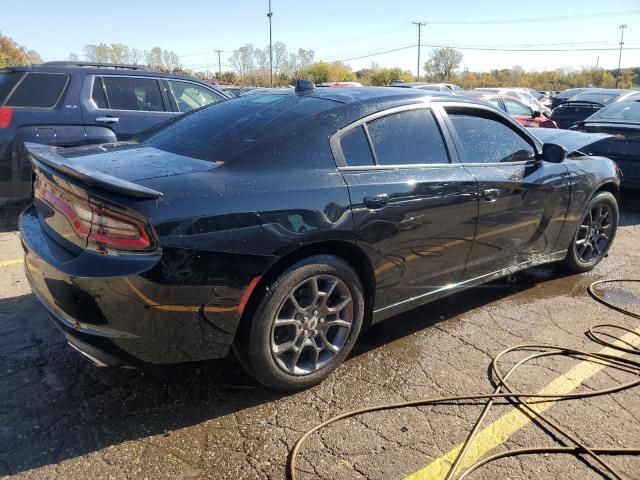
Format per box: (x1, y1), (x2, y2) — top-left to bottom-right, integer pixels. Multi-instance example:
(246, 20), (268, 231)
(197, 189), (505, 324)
(333, 108), (477, 320)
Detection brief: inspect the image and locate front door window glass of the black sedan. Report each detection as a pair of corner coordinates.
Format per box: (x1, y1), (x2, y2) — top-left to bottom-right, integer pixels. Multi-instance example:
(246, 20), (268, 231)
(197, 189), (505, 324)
(446, 108), (536, 163)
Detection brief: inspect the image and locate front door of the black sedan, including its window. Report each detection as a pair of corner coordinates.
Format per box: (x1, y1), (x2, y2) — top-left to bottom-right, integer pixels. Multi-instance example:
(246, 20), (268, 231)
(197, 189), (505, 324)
(446, 107), (570, 278)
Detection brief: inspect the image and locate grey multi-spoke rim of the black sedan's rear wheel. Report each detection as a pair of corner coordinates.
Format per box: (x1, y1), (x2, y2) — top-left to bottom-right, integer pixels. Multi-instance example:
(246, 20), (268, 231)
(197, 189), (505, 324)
(271, 274), (353, 375)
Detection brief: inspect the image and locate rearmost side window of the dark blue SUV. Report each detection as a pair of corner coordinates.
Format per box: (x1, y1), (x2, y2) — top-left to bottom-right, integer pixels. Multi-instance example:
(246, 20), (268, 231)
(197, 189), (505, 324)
(5, 72), (69, 108)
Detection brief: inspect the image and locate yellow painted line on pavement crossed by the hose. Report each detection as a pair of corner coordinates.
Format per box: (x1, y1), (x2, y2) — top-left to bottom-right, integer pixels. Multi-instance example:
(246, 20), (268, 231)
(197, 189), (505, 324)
(405, 327), (640, 480)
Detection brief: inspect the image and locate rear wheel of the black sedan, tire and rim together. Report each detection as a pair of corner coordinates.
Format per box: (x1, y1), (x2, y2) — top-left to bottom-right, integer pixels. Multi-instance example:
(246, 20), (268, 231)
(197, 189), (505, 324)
(234, 255), (364, 391)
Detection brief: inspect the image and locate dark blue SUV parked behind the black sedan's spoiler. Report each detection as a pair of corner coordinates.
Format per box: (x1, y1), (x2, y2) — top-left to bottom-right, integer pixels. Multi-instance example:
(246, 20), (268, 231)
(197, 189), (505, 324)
(0, 62), (228, 204)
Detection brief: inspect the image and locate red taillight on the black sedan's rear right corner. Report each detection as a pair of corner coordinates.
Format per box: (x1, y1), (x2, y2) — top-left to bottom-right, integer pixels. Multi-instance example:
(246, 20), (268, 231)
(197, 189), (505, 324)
(34, 180), (151, 250)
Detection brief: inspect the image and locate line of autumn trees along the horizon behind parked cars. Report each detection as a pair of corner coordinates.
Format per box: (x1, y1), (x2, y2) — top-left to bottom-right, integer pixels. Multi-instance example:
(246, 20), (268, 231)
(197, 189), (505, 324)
(0, 33), (640, 90)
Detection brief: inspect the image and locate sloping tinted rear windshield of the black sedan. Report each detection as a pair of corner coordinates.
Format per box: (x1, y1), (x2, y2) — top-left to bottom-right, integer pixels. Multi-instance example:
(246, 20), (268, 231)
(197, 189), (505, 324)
(139, 94), (336, 162)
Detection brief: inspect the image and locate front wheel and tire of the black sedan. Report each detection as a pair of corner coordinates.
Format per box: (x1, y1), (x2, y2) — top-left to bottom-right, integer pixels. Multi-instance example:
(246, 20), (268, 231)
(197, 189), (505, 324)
(564, 192), (620, 273)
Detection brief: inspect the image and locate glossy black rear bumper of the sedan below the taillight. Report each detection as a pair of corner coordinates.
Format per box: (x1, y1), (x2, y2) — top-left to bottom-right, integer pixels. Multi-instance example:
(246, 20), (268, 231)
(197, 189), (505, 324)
(20, 206), (243, 366)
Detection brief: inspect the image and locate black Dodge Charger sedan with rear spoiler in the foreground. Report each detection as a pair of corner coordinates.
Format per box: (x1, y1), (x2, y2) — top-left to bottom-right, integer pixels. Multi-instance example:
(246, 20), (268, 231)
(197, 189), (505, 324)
(20, 84), (619, 390)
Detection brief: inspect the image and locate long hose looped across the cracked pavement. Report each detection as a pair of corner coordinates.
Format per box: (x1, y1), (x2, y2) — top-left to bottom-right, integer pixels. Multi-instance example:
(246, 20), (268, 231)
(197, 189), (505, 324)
(287, 279), (640, 480)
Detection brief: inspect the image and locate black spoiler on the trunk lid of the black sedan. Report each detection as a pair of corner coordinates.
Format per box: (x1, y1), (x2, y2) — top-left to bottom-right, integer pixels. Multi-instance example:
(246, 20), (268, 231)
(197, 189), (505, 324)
(24, 142), (162, 198)
